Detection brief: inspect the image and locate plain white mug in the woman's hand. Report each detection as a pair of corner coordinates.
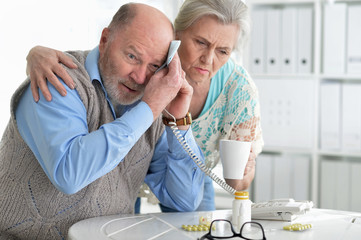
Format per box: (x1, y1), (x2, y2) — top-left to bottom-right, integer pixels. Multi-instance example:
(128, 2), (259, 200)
(219, 139), (252, 179)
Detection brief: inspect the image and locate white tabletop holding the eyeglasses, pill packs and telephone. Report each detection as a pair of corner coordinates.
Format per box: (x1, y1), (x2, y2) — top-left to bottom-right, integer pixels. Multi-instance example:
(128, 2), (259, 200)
(69, 209), (361, 240)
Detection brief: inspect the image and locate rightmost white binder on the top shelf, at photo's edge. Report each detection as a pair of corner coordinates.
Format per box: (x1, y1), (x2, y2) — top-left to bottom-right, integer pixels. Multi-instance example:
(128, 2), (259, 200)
(347, 5), (361, 74)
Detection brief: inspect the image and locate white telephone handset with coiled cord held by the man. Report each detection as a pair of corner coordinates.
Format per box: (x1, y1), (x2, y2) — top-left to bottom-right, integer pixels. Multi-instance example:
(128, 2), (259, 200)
(160, 40), (236, 195)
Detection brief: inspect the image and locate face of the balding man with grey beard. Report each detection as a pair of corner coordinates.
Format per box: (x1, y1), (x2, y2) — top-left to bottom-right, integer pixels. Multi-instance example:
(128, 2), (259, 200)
(99, 17), (173, 105)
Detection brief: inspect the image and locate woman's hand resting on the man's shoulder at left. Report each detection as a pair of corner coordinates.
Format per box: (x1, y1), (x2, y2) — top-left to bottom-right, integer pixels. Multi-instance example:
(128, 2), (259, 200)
(26, 46), (77, 102)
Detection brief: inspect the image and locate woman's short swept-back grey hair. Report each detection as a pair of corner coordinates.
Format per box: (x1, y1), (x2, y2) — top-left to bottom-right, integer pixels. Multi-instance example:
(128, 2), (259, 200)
(174, 0), (250, 51)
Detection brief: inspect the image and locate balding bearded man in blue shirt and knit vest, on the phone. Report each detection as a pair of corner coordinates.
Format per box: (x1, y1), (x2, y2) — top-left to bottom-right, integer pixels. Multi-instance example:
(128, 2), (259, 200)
(0, 3), (204, 239)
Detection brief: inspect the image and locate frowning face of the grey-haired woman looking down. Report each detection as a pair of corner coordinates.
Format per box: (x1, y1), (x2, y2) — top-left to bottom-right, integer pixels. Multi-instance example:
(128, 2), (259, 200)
(176, 16), (239, 82)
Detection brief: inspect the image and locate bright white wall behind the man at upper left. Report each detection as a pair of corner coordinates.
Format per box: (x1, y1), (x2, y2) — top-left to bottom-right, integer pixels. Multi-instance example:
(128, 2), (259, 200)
(0, 0), (182, 135)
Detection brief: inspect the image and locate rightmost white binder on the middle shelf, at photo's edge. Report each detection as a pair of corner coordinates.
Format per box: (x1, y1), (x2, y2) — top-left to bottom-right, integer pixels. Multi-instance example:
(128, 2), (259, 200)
(341, 83), (361, 152)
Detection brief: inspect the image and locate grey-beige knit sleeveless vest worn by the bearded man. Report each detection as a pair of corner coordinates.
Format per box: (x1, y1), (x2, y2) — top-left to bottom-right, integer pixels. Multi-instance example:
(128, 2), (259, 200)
(0, 52), (164, 240)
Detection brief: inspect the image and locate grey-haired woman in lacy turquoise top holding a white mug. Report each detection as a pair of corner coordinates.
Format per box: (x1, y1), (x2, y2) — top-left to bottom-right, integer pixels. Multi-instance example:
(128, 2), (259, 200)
(27, 0), (263, 211)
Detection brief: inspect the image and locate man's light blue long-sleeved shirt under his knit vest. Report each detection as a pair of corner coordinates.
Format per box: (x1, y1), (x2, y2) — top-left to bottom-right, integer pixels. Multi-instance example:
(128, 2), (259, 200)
(16, 47), (204, 211)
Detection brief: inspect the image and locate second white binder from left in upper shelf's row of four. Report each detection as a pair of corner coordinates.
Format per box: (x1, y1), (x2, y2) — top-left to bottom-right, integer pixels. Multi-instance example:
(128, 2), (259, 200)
(266, 8), (281, 74)
